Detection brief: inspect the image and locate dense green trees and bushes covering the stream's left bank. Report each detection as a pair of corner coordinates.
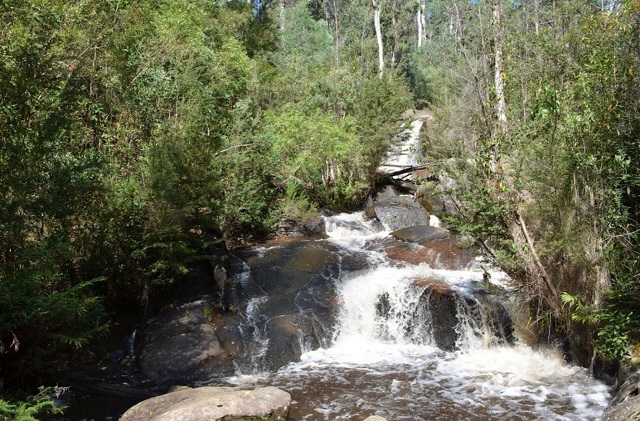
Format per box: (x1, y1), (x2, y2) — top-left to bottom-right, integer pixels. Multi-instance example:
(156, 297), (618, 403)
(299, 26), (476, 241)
(0, 0), (411, 406)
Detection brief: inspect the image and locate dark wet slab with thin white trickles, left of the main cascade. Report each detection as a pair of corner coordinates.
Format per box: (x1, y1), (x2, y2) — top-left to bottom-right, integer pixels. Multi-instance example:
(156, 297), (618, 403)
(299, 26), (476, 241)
(228, 241), (342, 370)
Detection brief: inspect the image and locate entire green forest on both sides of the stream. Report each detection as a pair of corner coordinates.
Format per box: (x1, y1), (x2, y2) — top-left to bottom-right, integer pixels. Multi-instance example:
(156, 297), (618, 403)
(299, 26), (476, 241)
(0, 0), (640, 419)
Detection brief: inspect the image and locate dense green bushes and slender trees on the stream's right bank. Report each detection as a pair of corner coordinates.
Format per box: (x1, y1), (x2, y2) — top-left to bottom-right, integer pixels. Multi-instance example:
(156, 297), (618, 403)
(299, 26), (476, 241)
(410, 0), (640, 363)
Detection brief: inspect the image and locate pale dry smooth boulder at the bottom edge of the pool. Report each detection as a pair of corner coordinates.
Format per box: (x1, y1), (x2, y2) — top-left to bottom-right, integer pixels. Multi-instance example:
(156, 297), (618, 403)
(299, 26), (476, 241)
(120, 386), (291, 421)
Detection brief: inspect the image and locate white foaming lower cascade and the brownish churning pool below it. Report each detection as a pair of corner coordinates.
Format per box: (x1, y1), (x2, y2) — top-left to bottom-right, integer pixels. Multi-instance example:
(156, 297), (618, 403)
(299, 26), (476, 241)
(212, 214), (610, 421)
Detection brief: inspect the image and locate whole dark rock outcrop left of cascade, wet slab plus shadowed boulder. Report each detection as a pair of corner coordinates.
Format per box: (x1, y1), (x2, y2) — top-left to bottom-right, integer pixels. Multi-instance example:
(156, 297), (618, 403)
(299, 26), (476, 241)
(136, 236), (369, 386)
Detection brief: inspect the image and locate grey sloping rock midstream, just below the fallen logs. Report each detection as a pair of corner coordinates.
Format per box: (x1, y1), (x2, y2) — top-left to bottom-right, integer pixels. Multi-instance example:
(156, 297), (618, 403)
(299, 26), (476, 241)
(366, 186), (429, 230)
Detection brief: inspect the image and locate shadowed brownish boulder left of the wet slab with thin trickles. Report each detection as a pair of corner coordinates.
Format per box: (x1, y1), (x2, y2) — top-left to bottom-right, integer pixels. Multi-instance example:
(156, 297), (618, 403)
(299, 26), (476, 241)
(137, 304), (233, 385)
